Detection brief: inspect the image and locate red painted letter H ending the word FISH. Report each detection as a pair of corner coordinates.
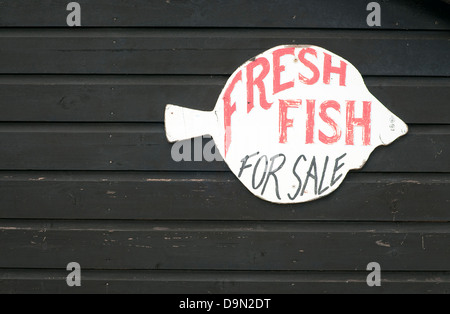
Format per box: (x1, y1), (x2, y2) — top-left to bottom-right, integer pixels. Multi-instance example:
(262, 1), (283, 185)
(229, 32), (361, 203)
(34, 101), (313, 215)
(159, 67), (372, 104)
(345, 100), (372, 146)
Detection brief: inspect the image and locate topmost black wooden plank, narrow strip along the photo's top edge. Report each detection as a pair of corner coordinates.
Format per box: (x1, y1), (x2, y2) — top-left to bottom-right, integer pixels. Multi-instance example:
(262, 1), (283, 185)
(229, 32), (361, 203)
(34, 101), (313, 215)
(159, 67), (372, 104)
(0, 0), (450, 29)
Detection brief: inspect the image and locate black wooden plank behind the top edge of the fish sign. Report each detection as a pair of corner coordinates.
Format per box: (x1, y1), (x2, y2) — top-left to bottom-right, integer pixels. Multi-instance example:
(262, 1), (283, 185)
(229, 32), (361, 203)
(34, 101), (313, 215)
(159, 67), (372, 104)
(0, 28), (450, 76)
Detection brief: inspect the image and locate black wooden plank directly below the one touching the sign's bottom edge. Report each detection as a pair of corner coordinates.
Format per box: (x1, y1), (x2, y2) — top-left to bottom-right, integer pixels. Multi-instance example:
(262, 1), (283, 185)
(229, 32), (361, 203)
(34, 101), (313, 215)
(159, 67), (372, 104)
(0, 220), (450, 271)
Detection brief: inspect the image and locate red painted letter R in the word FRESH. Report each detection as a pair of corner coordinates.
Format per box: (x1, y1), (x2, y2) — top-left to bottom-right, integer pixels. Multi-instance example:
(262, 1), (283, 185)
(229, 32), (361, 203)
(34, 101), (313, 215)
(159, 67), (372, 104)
(247, 58), (272, 113)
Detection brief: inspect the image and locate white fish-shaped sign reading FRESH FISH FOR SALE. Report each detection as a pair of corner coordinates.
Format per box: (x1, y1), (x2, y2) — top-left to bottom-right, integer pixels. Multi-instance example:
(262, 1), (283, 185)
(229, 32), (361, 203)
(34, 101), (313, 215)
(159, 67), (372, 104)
(165, 45), (408, 203)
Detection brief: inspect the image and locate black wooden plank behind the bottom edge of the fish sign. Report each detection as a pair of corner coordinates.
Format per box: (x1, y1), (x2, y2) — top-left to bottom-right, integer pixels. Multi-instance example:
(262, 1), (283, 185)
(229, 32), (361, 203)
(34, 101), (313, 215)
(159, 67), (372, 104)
(0, 171), (450, 222)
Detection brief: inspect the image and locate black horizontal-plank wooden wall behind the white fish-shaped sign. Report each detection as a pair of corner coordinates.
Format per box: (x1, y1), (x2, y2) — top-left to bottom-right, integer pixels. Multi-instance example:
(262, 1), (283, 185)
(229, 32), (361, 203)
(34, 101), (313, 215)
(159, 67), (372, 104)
(0, 0), (450, 293)
